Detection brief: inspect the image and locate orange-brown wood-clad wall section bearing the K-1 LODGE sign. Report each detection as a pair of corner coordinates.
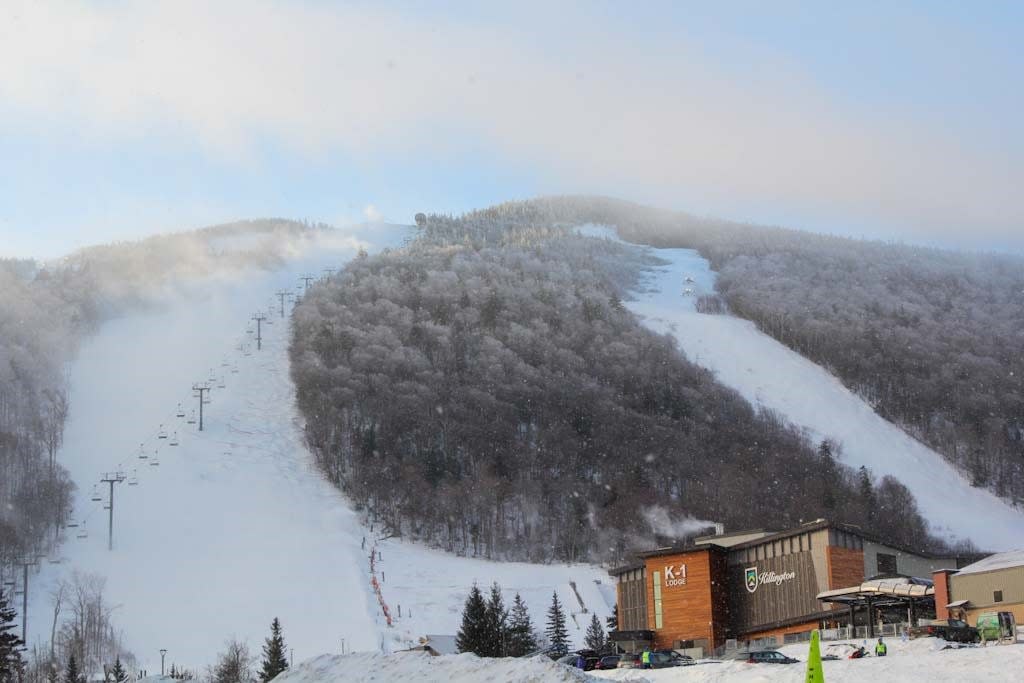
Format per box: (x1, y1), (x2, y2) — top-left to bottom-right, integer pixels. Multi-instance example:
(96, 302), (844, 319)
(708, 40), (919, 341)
(646, 549), (726, 648)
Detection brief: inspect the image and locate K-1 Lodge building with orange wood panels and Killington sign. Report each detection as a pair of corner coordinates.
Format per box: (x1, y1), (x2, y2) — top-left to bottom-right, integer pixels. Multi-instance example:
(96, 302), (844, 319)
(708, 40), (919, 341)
(610, 519), (970, 652)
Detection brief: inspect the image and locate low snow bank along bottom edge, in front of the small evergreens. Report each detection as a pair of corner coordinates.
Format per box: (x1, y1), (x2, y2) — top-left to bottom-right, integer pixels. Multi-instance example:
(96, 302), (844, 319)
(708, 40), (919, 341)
(273, 652), (595, 683)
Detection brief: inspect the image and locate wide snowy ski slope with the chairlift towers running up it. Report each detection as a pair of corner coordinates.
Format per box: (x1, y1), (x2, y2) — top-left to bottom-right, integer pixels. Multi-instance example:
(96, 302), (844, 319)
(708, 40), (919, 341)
(29, 226), (614, 673)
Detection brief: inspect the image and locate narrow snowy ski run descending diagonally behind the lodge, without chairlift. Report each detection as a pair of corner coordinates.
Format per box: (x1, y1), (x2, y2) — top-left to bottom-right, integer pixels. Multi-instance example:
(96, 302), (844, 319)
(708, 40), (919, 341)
(582, 226), (1024, 551)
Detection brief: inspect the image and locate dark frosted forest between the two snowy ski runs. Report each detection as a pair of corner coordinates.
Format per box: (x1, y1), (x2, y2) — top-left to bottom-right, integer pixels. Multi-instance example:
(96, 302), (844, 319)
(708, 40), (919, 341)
(291, 204), (934, 561)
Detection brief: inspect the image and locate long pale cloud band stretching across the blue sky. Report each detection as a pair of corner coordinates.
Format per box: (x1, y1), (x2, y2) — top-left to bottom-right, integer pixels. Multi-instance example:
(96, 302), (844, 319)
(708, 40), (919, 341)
(0, 0), (1024, 240)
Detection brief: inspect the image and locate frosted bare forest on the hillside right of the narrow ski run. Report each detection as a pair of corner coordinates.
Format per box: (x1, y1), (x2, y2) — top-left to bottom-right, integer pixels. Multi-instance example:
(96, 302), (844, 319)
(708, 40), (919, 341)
(517, 198), (1024, 505)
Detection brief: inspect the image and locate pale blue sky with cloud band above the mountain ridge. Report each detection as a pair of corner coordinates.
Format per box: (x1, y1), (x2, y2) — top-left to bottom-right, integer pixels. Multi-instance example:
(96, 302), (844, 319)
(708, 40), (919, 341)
(0, 0), (1024, 258)
